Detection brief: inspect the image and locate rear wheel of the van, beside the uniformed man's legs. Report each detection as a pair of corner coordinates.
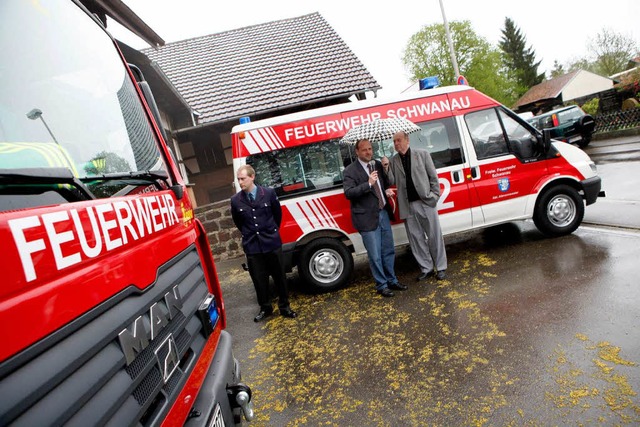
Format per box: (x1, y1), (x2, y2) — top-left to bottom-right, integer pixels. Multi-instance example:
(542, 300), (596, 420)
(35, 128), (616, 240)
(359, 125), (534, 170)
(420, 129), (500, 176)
(298, 238), (353, 292)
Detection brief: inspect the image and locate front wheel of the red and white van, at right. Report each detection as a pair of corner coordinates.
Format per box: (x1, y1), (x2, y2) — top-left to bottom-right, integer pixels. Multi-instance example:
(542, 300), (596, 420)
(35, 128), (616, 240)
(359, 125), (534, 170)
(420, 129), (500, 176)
(533, 184), (584, 237)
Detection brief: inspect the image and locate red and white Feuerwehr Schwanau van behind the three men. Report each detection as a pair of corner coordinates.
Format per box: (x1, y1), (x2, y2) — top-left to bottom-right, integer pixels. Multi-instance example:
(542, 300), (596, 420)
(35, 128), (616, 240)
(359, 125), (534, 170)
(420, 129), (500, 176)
(232, 85), (601, 290)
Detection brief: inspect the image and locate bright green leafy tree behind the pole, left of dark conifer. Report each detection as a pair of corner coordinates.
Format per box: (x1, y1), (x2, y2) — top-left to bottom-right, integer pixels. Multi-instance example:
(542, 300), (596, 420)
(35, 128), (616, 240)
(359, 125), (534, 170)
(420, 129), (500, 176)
(402, 21), (517, 105)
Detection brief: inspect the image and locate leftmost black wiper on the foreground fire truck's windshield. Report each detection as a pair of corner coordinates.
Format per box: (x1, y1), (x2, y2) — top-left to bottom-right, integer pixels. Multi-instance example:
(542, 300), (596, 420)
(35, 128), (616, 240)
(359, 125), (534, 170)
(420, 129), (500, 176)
(0, 168), (96, 200)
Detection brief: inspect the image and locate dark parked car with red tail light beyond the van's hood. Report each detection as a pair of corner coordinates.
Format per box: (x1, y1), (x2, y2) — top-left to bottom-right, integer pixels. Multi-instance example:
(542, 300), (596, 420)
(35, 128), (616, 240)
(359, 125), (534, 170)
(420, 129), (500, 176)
(527, 105), (596, 148)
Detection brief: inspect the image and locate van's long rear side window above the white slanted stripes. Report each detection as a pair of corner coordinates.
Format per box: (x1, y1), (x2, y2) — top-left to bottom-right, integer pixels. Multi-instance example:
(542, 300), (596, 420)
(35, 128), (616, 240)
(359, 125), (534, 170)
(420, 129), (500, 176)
(247, 140), (353, 198)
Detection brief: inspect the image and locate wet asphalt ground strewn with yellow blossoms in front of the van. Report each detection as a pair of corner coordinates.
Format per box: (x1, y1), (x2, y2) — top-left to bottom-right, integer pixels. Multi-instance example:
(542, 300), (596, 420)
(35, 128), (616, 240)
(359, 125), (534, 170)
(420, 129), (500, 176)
(217, 138), (640, 426)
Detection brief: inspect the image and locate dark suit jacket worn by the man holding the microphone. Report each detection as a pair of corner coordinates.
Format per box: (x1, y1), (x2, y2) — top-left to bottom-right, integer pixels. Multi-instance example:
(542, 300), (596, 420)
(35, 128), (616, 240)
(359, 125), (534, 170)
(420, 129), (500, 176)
(342, 159), (393, 231)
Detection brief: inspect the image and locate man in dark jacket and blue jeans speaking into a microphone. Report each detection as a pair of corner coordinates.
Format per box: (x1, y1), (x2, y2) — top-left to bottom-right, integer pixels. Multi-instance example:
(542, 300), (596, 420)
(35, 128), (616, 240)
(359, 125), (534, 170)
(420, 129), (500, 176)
(343, 139), (407, 297)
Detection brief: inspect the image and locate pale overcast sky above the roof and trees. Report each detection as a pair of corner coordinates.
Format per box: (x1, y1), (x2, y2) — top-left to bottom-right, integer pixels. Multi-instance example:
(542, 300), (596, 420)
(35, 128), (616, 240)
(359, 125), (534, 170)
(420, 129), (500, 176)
(108, 0), (640, 95)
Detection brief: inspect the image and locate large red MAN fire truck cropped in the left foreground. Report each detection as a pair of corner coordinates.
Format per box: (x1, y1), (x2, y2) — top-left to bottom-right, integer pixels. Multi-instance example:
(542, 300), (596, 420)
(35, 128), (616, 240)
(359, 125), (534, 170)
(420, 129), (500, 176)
(0, 0), (253, 426)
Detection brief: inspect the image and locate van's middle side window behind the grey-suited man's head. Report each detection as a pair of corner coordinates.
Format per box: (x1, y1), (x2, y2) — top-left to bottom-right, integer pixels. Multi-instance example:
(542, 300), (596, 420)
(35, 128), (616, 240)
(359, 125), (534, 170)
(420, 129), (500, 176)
(374, 117), (464, 168)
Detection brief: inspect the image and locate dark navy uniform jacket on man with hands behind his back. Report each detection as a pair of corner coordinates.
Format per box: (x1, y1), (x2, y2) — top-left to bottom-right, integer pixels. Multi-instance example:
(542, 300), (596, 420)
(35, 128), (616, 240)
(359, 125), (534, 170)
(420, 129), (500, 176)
(231, 185), (282, 255)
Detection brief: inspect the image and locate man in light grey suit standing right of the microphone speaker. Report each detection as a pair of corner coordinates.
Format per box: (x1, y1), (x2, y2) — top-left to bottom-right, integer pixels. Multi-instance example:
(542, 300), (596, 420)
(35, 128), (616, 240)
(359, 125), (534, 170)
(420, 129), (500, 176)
(382, 132), (447, 281)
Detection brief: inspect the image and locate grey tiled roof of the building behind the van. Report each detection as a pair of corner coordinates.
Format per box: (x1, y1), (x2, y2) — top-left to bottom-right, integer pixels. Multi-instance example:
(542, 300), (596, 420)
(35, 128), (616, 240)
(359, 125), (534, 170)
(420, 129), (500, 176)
(143, 12), (380, 124)
